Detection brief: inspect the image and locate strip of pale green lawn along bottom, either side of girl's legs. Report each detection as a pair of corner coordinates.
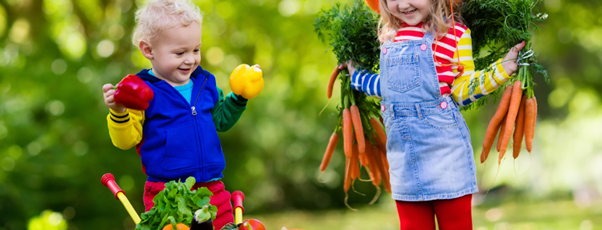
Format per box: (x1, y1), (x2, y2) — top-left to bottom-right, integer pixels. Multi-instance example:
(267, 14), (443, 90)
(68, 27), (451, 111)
(244, 197), (602, 230)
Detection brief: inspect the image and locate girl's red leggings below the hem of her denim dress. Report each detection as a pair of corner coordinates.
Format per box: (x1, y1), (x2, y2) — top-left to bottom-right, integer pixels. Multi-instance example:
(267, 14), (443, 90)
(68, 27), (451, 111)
(395, 194), (472, 230)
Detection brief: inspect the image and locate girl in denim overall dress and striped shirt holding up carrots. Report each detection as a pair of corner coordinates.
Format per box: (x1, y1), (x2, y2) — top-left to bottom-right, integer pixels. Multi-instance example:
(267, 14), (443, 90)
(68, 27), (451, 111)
(346, 0), (524, 230)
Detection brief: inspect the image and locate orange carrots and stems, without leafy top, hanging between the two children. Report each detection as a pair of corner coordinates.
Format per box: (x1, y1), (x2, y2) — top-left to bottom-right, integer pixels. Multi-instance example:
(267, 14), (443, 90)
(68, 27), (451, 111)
(320, 66), (391, 205)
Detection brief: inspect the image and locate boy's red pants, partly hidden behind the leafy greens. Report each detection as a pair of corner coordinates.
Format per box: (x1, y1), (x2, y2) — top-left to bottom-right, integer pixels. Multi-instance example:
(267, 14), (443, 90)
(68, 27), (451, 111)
(144, 181), (234, 229)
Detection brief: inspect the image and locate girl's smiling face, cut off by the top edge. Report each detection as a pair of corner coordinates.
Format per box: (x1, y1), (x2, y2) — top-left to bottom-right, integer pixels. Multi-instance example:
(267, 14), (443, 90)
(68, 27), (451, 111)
(387, 0), (431, 26)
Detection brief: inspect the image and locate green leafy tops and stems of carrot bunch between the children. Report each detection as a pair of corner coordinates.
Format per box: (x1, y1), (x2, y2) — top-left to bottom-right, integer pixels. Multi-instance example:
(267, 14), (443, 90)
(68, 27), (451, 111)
(314, 0), (380, 131)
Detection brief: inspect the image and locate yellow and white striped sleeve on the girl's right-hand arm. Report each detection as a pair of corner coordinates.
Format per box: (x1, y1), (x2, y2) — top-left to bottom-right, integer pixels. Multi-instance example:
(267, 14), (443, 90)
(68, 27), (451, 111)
(451, 29), (510, 106)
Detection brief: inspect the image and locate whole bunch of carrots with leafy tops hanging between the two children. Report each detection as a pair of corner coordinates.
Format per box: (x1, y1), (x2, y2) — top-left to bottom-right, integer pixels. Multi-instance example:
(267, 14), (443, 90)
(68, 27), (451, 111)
(314, 0), (391, 203)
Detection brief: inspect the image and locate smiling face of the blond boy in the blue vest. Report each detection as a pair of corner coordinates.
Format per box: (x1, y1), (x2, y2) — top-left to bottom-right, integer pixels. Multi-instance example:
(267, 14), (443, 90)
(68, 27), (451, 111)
(151, 22), (202, 86)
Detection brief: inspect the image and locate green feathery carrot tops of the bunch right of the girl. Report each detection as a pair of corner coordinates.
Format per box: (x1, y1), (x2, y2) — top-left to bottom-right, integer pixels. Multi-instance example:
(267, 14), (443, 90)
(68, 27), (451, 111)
(462, 0), (549, 110)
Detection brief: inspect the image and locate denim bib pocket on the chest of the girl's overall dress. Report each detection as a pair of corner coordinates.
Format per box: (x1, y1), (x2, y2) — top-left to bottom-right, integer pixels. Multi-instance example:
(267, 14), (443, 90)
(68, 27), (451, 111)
(386, 54), (420, 93)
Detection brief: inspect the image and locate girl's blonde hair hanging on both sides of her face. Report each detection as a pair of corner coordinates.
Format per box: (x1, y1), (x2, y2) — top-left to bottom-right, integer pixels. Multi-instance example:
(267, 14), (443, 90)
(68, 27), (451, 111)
(378, 0), (464, 43)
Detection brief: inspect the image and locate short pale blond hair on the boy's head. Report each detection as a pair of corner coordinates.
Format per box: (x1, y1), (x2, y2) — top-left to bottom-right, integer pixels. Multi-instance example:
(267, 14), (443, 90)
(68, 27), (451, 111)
(132, 0), (203, 46)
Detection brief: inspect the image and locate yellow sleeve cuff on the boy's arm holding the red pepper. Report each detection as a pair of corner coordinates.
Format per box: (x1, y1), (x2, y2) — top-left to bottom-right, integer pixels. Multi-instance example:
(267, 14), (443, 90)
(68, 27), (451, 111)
(107, 109), (144, 150)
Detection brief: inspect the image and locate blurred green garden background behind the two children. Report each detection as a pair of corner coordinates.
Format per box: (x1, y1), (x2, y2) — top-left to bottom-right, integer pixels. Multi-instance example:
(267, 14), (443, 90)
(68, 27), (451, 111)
(0, 0), (602, 230)
